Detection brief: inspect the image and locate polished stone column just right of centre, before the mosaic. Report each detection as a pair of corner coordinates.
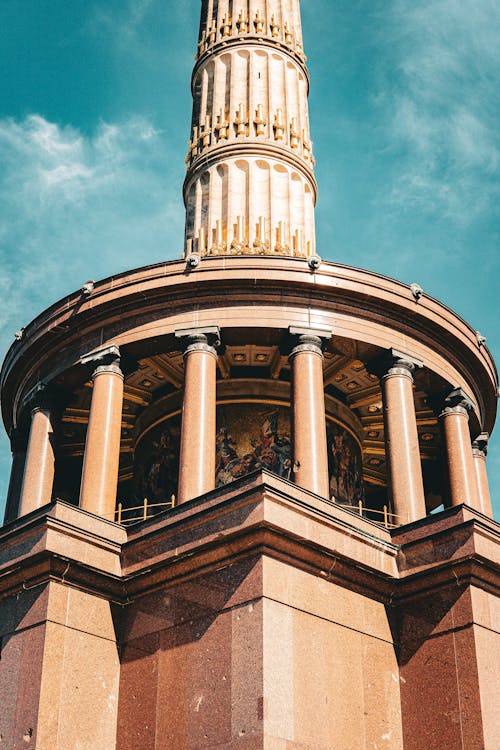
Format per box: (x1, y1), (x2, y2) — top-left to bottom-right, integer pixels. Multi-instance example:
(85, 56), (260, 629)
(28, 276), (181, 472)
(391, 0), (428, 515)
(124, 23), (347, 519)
(289, 328), (331, 498)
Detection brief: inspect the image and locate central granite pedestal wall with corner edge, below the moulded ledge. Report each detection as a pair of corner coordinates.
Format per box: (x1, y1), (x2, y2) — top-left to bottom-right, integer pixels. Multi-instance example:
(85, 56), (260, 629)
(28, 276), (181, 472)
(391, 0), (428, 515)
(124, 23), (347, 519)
(117, 555), (402, 750)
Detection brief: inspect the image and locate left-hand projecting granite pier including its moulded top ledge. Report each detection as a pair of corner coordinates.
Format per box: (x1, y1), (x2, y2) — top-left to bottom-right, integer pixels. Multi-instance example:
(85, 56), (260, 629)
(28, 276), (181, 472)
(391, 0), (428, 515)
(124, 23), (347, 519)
(0, 504), (125, 750)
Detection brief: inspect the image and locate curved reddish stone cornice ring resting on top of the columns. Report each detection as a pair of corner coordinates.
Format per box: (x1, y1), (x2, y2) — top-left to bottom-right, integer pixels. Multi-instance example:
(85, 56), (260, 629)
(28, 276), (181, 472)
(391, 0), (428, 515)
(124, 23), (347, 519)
(0, 256), (498, 432)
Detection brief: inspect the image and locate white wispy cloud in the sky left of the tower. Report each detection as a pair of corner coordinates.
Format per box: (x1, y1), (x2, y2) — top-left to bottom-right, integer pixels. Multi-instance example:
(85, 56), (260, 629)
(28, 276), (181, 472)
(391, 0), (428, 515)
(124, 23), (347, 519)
(0, 115), (182, 340)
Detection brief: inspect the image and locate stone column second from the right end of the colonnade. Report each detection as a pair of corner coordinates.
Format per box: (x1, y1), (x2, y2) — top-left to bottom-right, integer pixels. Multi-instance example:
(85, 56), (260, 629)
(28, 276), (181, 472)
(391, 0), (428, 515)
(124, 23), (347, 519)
(439, 388), (480, 510)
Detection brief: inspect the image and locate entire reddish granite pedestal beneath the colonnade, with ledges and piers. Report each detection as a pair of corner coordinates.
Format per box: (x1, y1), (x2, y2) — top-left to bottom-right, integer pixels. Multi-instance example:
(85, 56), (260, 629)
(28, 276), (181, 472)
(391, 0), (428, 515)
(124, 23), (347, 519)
(0, 473), (500, 750)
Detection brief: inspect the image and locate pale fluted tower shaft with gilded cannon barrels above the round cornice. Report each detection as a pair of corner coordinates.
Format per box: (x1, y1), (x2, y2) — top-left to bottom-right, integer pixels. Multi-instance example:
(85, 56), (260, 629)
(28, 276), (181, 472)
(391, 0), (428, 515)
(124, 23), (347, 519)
(184, 0), (317, 258)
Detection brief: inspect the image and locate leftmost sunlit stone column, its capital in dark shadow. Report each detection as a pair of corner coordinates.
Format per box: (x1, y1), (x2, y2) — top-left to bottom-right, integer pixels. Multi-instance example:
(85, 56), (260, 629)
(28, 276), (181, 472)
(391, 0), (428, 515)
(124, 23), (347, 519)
(19, 385), (55, 516)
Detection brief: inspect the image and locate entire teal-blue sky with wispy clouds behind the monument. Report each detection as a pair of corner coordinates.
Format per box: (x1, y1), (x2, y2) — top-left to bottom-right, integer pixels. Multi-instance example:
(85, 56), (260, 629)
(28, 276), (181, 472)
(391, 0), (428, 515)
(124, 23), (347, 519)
(0, 0), (500, 517)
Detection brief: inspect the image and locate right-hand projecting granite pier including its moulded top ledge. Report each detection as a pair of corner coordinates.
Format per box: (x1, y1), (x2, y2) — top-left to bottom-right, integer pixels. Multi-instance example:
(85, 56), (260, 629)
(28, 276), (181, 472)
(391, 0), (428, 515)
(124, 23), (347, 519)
(393, 506), (500, 750)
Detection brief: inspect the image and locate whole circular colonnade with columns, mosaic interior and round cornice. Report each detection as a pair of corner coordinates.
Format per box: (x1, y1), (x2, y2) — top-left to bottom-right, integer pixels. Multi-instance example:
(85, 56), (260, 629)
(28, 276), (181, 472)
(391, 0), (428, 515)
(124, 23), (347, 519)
(1, 256), (498, 525)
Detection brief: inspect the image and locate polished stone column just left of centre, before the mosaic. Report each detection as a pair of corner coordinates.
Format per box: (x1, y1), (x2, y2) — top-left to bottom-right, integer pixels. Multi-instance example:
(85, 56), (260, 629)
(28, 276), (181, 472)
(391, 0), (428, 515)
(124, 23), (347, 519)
(175, 326), (220, 504)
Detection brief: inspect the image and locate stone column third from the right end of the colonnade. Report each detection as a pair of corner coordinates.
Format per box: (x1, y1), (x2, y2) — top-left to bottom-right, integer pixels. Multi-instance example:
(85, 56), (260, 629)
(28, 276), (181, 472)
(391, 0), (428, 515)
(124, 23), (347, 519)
(381, 349), (426, 524)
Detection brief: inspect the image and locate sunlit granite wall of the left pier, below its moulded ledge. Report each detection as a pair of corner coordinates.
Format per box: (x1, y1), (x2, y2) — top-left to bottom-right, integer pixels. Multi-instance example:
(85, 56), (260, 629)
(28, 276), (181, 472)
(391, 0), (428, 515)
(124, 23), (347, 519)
(0, 583), (120, 750)
